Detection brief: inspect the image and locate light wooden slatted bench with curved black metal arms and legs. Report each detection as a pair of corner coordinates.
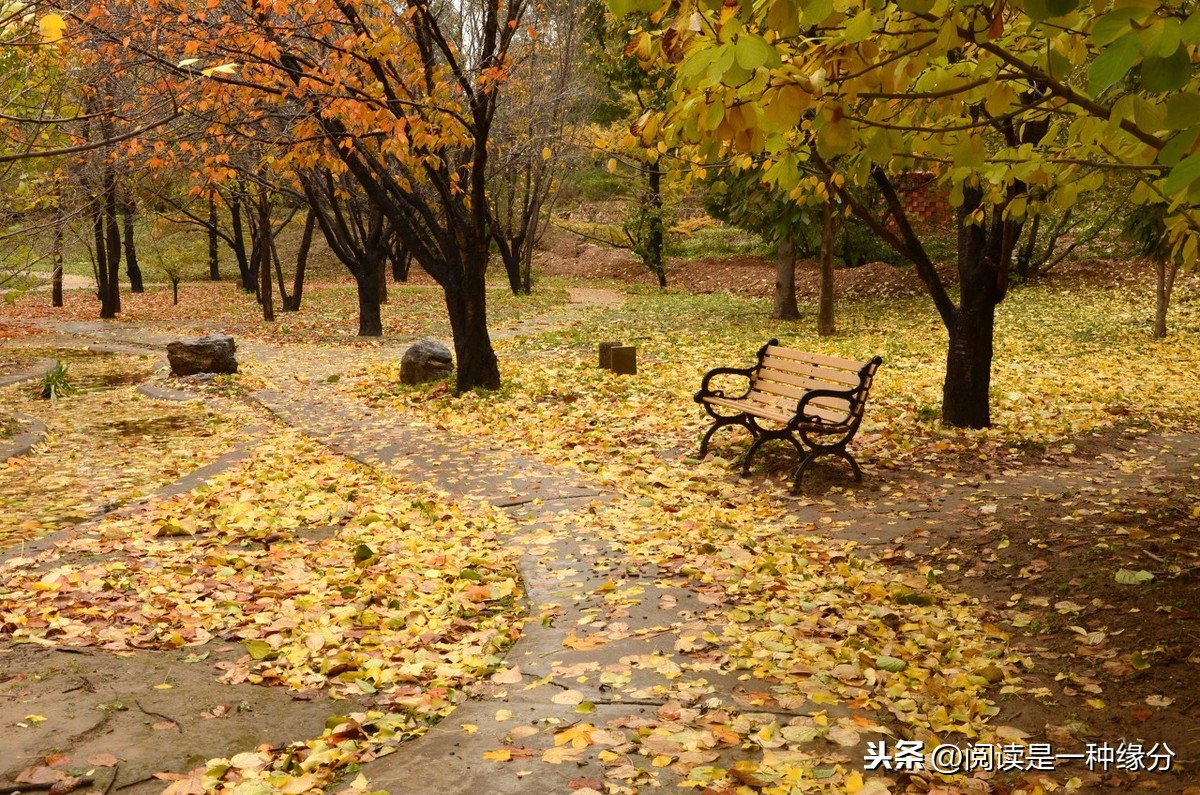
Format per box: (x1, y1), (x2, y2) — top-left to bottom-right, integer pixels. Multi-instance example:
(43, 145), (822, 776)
(696, 340), (883, 494)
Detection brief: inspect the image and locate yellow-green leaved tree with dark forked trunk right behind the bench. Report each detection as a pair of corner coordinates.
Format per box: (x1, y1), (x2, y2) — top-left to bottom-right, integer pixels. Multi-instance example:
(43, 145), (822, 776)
(612, 0), (1200, 428)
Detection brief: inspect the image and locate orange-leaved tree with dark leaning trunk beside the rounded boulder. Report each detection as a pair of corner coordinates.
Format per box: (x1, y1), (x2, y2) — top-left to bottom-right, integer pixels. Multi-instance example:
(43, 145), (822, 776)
(119, 0), (528, 390)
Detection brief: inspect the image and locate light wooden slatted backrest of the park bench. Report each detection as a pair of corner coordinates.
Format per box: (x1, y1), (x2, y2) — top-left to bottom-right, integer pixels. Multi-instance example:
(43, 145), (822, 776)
(750, 340), (882, 425)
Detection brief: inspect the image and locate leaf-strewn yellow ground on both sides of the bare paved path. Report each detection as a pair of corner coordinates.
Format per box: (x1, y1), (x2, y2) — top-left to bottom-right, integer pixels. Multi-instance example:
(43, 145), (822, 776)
(0, 256), (1200, 795)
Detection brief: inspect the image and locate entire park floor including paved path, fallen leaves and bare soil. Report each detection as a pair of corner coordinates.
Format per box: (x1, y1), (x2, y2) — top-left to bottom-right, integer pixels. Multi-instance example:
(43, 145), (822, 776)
(0, 250), (1200, 795)
